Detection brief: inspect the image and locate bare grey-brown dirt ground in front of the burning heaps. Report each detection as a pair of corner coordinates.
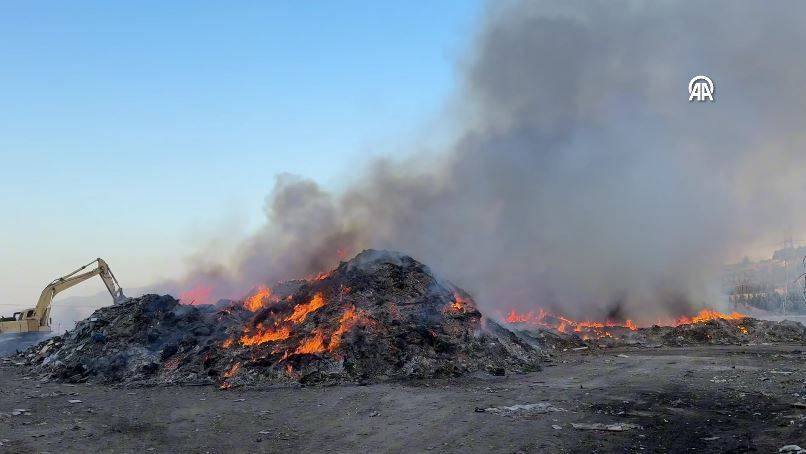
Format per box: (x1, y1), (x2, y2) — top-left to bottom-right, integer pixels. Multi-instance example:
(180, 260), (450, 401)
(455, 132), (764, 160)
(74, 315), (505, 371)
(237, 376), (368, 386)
(0, 345), (806, 453)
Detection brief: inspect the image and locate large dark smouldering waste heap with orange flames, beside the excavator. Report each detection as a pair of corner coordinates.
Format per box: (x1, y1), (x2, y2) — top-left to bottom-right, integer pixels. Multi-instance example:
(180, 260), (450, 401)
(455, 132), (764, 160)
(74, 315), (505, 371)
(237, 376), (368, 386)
(21, 250), (543, 388)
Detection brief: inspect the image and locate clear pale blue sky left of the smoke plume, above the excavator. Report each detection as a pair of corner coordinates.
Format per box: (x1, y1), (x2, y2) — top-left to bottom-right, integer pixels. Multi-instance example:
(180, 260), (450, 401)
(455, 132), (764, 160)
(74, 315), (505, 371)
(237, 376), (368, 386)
(0, 0), (483, 306)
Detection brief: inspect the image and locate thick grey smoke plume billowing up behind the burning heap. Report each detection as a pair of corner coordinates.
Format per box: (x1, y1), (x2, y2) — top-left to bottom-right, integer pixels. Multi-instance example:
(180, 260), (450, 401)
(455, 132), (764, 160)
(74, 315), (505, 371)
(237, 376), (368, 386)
(174, 0), (806, 320)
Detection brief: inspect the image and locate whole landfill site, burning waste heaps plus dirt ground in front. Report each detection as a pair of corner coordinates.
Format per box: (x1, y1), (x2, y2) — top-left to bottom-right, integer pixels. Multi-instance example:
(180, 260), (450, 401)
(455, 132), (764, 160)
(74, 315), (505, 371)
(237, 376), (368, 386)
(0, 250), (806, 453)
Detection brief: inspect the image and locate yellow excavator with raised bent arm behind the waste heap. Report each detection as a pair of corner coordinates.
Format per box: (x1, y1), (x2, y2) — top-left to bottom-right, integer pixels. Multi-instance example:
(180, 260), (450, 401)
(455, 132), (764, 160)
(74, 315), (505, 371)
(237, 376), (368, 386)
(0, 258), (128, 334)
